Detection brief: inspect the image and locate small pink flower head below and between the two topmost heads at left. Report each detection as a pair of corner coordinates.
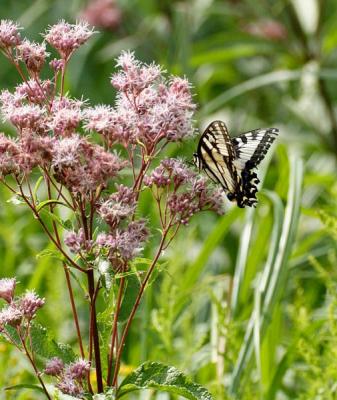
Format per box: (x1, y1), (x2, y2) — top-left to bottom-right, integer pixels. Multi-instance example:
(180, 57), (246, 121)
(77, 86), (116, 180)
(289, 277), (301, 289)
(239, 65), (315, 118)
(18, 39), (49, 73)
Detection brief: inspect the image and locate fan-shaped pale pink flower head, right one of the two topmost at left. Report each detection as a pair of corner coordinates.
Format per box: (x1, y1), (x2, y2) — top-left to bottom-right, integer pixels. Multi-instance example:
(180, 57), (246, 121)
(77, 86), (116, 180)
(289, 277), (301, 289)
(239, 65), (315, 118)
(44, 20), (94, 60)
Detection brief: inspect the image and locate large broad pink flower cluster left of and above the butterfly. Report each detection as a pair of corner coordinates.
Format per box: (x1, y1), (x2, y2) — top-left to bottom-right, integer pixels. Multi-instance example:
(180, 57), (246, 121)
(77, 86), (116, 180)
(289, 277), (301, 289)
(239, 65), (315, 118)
(85, 52), (195, 148)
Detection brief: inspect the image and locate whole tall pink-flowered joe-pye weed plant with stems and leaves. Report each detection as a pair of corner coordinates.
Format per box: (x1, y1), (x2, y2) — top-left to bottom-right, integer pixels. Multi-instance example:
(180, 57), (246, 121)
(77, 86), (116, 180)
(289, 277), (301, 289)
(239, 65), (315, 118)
(0, 20), (222, 399)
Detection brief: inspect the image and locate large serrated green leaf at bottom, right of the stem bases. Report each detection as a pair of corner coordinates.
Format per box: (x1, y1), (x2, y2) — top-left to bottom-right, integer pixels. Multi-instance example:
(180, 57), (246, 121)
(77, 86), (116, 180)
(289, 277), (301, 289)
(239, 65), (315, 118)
(117, 362), (212, 400)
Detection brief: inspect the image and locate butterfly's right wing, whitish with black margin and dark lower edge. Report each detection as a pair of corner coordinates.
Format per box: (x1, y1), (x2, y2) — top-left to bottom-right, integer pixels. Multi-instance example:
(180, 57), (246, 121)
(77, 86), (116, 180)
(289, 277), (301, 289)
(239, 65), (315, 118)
(232, 128), (278, 206)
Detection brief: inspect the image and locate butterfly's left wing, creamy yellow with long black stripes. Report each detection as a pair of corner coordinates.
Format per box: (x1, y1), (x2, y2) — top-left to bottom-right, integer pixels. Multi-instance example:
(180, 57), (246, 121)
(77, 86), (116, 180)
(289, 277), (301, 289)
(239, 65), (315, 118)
(196, 121), (237, 197)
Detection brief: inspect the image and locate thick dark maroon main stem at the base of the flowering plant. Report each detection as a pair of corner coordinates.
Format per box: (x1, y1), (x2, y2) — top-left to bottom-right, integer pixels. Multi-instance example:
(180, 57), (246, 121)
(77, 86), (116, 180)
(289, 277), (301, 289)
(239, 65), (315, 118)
(87, 269), (103, 393)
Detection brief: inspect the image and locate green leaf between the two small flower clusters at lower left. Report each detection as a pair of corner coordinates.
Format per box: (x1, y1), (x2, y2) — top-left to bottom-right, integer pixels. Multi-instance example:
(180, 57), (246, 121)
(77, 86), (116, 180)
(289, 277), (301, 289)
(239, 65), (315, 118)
(31, 324), (75, 363)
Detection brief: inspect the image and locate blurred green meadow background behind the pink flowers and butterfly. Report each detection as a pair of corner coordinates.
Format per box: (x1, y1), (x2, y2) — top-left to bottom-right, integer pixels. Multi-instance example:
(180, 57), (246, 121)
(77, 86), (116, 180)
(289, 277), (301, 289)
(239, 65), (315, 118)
(0, 0), (337, 400)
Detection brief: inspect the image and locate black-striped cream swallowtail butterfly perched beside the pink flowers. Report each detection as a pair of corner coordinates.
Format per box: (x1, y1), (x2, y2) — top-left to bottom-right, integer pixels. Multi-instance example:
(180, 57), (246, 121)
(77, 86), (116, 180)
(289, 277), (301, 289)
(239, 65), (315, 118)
(193, 121), (279, 208)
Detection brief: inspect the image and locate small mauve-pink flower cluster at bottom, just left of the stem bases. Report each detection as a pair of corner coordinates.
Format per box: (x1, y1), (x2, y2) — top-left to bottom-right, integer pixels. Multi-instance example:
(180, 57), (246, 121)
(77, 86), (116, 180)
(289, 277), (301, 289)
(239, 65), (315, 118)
(44, 357), (90, 398)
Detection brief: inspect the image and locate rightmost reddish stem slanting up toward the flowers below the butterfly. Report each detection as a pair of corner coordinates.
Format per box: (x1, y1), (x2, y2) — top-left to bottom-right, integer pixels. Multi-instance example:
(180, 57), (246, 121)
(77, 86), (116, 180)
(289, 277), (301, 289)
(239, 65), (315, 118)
(112, 229), (169, 391)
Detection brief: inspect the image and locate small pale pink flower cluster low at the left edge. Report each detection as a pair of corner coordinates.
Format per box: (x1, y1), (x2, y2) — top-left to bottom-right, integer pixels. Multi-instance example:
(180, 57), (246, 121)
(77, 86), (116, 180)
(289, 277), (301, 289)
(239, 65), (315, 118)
(0, 278), (44, 332)
